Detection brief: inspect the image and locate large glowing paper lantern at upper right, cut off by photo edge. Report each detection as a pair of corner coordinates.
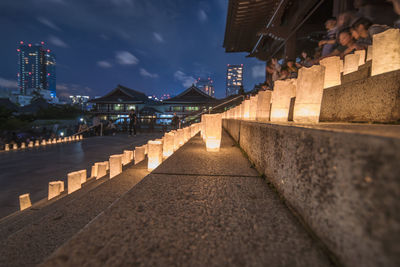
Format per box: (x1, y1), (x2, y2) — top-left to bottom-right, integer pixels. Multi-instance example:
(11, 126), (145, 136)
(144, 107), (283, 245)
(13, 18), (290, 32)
(371, 29), (400, 76)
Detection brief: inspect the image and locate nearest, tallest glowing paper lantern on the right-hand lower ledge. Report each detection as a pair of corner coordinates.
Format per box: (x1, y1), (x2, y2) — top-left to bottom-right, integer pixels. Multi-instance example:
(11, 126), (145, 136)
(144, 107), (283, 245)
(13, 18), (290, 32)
(293, 65), (325, 123)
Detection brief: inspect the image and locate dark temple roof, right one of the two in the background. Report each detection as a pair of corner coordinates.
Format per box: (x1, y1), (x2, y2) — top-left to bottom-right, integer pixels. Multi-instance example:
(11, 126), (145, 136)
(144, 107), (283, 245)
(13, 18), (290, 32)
(163, 85), (218, 104)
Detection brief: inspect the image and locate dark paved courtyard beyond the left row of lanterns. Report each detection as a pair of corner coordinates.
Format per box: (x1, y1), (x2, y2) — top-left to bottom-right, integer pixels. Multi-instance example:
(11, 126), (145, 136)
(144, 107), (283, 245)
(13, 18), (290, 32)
(0, 133), (161, 218)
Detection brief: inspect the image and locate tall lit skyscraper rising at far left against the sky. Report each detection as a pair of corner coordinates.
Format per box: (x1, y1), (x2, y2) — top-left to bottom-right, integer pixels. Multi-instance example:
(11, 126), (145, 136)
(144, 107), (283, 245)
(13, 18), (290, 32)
(17, 41), (56, 97)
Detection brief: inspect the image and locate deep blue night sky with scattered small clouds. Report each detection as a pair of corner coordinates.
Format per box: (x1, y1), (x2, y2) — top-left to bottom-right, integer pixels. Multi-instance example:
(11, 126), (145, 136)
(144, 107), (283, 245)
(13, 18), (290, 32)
(0, 0), (265, 98)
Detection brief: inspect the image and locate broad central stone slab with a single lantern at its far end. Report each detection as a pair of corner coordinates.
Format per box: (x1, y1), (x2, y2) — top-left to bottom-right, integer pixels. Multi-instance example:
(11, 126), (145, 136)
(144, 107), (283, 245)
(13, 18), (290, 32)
(42, 134), (332, 267)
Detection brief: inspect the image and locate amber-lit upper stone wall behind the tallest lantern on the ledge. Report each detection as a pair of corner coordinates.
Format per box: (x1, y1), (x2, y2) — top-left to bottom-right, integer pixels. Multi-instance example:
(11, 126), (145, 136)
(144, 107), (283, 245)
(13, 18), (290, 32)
(319, 71), (400, 122)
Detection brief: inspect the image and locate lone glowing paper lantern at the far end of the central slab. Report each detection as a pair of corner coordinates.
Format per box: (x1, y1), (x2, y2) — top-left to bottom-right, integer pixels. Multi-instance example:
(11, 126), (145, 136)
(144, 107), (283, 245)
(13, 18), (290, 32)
(205, 114), (222, 152)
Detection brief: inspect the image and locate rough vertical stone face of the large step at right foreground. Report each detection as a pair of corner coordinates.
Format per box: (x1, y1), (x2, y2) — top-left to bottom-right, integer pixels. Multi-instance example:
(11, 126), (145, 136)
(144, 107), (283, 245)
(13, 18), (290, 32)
(223, 120), (400, 267)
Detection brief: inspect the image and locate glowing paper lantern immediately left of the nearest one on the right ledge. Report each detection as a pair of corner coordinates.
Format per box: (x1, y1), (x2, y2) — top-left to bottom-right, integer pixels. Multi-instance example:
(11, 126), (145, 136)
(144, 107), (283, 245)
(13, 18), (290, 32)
(271, 79), (297, 122)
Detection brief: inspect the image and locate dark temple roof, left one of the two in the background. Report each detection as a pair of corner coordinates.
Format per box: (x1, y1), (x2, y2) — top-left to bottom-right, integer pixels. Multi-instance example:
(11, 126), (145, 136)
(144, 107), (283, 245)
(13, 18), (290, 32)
(89, 84), (156, 104)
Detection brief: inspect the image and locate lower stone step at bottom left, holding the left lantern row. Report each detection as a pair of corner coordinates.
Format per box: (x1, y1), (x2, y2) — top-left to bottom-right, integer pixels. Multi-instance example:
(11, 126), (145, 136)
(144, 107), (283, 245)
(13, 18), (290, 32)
(0, 160), (148, 266)
